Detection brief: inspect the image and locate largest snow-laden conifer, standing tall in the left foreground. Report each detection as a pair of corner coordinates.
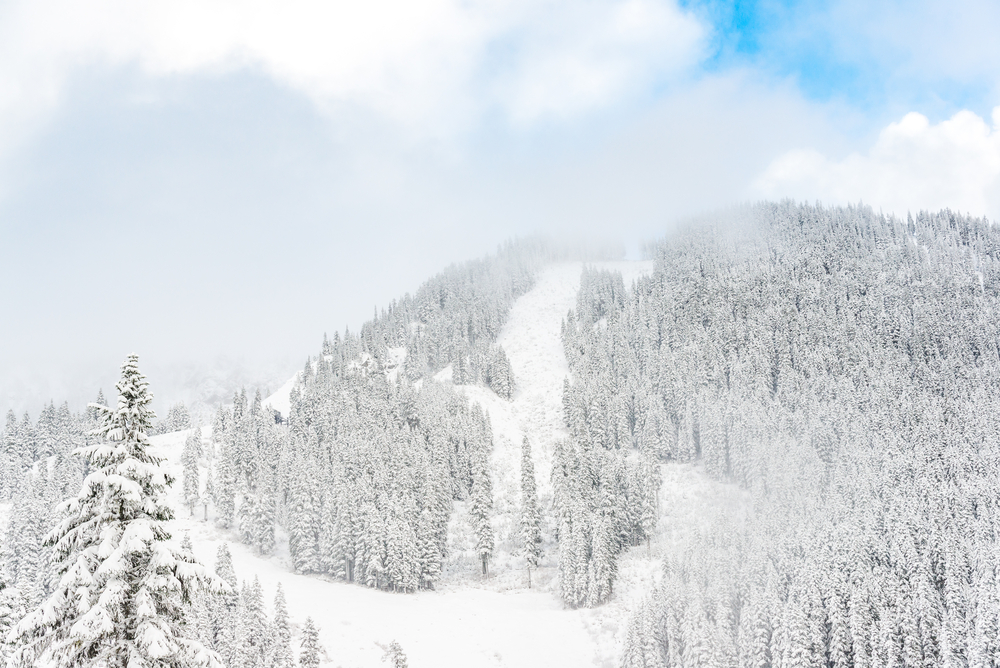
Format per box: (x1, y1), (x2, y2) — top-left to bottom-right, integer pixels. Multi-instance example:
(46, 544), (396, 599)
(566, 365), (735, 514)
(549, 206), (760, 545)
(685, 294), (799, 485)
(11, 355), (225, 668)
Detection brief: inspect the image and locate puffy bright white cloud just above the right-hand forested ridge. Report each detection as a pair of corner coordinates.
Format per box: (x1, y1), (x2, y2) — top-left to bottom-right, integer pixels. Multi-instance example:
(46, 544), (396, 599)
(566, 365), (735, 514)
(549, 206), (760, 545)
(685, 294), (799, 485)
(753, 107), (1000, 219)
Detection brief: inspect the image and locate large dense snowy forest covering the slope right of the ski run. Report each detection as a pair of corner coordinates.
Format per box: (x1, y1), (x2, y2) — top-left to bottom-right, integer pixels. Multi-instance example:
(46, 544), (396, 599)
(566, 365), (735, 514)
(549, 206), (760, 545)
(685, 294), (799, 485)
(554, 202), (1000, 668)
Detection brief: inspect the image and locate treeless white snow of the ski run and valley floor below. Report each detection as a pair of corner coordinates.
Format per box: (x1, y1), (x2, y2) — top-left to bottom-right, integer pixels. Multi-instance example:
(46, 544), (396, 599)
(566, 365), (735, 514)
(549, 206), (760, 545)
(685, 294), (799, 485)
(146, 262), (748, 668)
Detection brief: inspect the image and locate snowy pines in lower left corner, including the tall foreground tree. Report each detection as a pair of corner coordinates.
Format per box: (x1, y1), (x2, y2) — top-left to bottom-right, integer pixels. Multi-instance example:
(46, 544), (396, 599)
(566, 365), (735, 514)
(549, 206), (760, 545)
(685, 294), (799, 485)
(0, 355), (320, 668)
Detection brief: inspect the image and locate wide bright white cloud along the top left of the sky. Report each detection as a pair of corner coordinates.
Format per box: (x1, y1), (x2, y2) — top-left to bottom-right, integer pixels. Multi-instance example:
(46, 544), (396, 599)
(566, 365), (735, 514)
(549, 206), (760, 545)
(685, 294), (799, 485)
(0, 0), (704, 146)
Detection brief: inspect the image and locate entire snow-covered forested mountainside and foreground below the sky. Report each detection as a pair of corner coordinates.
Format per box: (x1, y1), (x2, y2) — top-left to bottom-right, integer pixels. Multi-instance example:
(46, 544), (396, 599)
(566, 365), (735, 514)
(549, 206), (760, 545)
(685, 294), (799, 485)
(0, 200), (1000, 668)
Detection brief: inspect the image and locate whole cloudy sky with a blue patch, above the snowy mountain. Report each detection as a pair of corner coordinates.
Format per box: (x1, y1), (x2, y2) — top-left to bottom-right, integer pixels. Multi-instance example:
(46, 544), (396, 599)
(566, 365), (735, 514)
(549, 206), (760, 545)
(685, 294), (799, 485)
(0, 0), (1000, 416)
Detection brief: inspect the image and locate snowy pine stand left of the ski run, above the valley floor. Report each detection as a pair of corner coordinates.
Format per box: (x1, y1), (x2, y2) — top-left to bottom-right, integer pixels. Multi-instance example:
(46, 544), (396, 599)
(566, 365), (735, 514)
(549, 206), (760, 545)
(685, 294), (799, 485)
(212, 370), (493, 591)
